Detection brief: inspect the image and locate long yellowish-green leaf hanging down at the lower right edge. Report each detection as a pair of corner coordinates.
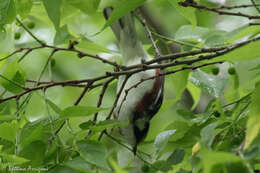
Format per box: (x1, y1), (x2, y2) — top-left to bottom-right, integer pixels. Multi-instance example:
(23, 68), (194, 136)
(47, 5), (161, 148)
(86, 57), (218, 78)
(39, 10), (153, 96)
(245, 84), (260, 149)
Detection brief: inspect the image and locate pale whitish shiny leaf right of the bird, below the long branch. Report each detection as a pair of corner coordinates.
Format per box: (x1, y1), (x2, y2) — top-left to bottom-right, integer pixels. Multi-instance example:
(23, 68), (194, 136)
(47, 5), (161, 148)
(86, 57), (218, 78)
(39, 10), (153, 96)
(190, 70), (228, 98)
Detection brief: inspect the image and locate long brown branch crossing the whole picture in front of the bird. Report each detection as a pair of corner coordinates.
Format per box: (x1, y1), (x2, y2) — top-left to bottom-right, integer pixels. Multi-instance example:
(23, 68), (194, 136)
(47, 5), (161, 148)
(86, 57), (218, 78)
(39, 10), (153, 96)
(0, 36), (260, 103)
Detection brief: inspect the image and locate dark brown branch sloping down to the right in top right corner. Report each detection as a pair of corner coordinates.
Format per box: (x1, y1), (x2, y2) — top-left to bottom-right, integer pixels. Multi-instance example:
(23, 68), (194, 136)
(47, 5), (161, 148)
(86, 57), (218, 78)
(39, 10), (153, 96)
(179, 2), (260, 19)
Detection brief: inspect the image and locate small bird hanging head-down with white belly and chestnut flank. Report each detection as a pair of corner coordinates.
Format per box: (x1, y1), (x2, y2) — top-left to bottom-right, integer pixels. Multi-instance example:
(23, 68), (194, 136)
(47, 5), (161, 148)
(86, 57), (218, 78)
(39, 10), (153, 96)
(103, 7), (164, 155)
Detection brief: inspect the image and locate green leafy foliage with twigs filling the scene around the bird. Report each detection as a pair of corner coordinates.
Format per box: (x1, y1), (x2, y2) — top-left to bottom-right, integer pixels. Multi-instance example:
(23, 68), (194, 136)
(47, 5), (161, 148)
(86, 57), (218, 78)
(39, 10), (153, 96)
(0, 0), (260, 173)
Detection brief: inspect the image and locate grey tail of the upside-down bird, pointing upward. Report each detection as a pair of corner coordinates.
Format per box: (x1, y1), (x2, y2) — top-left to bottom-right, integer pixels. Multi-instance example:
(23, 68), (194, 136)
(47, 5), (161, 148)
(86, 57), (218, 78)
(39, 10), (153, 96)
(103, 7), (138, 47)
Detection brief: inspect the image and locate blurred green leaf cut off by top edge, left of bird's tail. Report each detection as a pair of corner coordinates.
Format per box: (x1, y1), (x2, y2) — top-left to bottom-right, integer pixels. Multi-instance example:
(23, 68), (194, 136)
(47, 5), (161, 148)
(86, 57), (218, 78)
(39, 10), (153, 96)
(66, 0), (100, 14)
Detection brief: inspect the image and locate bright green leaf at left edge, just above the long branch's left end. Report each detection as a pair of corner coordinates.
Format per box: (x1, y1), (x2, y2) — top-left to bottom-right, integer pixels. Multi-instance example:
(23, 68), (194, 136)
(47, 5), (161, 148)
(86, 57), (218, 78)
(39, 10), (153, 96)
(0, 61), (26, 94)
